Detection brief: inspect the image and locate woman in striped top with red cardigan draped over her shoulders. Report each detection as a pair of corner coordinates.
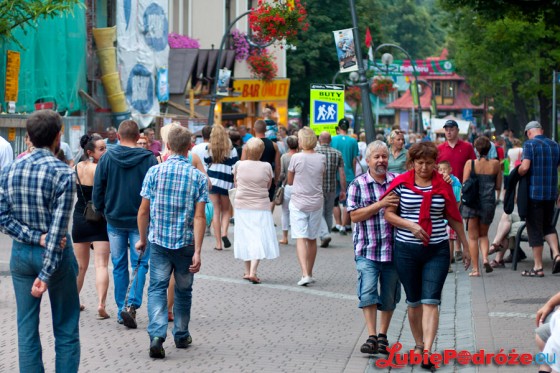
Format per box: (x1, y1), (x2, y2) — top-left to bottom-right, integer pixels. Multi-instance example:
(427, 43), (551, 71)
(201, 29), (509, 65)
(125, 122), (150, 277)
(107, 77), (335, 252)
(385, 142), (470, 368)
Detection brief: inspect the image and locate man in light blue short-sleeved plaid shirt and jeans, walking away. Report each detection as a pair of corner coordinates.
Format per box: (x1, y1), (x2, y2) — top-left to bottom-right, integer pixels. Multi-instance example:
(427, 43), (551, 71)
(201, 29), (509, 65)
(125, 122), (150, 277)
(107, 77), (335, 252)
(136, 127), (209, 359)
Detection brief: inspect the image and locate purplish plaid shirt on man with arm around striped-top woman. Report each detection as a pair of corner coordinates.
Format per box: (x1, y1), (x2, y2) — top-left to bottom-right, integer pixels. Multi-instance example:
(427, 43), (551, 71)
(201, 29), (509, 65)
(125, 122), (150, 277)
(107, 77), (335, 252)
(346, 172), (396, 262)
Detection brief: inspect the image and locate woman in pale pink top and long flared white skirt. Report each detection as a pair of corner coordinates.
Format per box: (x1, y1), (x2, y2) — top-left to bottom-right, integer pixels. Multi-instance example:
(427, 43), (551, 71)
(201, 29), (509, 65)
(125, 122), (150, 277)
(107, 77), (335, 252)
(233, 138), (279, 284)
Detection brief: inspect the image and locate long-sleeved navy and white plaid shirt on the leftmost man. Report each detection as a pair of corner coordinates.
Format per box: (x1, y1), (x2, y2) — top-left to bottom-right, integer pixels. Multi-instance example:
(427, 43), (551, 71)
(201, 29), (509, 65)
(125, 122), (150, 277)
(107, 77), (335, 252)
(0, 148), (76, 284)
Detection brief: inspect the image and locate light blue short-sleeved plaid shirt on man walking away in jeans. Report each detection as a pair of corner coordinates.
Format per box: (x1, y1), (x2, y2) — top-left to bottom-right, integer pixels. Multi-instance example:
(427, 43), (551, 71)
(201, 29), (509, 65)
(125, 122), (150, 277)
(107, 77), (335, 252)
(140, 155), (209, 250)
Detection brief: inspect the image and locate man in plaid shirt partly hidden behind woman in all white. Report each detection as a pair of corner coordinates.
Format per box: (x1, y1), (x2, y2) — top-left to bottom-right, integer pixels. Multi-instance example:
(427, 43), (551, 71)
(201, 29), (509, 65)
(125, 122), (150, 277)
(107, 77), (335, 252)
(315, 131), (346, 247)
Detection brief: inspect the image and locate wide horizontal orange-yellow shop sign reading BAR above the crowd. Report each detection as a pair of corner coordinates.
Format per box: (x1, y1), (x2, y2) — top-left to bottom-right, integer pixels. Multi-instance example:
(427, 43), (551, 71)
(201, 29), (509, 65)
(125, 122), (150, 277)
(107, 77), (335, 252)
(220, 79), (290, 102)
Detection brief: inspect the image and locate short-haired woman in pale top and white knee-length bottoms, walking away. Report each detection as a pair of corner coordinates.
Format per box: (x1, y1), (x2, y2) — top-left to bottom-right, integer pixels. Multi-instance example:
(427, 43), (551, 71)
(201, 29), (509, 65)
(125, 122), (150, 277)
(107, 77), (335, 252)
(288, 127), (327, 286)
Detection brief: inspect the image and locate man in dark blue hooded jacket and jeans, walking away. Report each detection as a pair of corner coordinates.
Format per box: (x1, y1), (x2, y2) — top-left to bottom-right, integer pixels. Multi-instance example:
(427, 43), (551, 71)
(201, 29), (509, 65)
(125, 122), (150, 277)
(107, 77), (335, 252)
(93, 120), (157, 329)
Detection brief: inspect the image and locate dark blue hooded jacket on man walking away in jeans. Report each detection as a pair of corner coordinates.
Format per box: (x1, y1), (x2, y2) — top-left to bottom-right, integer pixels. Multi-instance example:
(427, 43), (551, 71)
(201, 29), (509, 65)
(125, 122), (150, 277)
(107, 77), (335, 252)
(93, 145), (157, 228)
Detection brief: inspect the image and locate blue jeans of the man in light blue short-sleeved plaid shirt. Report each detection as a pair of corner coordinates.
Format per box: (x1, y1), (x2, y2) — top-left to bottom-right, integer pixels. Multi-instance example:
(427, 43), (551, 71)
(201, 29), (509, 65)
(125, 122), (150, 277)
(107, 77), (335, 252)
(148, 243), (194, 341)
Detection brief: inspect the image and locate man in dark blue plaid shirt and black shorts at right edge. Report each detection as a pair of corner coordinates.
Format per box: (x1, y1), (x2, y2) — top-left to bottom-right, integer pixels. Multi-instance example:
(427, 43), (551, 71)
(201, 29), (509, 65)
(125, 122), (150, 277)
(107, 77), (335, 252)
(518, 121), (560, 277)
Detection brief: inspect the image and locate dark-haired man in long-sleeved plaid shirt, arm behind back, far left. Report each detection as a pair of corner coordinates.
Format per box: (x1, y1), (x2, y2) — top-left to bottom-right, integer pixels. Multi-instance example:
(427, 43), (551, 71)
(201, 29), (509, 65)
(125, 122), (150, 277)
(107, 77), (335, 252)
(0, 110), (80, 372)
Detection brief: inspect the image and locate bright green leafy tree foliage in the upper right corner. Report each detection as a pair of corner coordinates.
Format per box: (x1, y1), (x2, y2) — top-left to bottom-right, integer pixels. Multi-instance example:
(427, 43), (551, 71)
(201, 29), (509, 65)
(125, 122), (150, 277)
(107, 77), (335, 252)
(441, 0), (560, 135)
